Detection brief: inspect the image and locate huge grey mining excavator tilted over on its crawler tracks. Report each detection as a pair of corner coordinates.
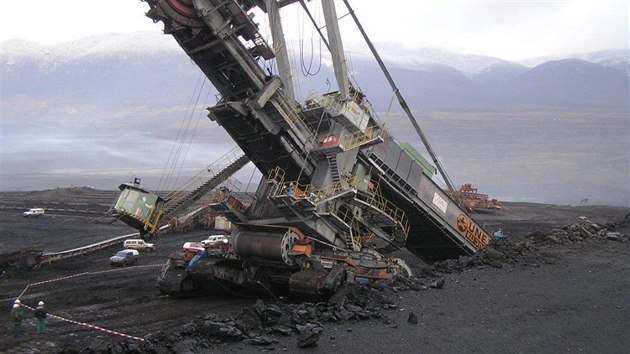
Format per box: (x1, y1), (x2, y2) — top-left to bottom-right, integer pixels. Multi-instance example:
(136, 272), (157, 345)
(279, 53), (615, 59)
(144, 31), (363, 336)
(113, 0), (490, 298)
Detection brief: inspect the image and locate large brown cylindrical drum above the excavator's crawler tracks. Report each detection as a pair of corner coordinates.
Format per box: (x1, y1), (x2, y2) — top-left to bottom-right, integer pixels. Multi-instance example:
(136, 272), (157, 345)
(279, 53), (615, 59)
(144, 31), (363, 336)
(231, 229), (299, 265)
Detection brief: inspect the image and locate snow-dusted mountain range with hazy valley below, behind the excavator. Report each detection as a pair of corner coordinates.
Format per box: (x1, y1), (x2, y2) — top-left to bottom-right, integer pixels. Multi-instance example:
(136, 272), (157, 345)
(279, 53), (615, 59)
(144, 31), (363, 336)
(0, 32), (630, 205)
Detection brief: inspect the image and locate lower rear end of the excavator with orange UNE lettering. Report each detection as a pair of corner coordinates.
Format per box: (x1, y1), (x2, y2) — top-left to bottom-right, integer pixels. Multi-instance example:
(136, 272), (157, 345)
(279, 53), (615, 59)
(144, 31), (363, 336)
(362, 135), (490, 262)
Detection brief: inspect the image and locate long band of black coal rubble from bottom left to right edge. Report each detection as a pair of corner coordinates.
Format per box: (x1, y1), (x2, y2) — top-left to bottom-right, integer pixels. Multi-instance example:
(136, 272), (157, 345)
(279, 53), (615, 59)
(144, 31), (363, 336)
(62, 217), (630, 353)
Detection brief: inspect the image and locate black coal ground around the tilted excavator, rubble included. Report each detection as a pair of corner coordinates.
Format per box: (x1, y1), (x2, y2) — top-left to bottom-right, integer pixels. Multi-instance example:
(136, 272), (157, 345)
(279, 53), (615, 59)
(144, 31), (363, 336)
(0, 205), (630, 353)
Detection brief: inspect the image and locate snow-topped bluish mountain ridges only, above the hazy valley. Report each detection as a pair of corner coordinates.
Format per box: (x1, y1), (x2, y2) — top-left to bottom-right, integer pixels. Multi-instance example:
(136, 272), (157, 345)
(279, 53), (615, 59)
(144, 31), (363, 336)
(0, 32), (630, 111)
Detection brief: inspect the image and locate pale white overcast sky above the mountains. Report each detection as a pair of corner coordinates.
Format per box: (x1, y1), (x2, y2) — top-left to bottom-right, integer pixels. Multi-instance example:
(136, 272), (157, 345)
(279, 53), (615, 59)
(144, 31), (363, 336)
(0, 0), (629, 60)
